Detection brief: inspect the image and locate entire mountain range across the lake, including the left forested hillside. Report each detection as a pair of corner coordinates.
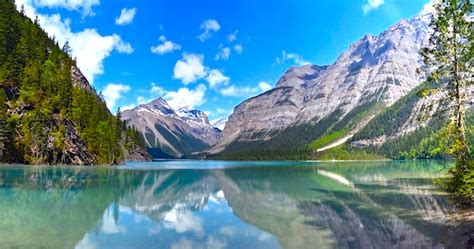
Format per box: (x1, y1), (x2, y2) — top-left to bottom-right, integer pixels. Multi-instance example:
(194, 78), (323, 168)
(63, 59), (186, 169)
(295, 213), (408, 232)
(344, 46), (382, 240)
(0, 1), (474, 164)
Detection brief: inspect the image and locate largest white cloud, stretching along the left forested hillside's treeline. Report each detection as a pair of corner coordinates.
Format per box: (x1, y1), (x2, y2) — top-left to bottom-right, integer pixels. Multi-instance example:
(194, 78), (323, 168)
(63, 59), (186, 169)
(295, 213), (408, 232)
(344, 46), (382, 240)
(16, 0), (133, 84)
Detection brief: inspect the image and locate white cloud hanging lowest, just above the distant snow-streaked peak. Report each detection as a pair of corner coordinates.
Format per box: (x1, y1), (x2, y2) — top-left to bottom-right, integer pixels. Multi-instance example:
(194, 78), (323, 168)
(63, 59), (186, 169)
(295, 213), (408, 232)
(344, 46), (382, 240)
(163, 84), (206, 110)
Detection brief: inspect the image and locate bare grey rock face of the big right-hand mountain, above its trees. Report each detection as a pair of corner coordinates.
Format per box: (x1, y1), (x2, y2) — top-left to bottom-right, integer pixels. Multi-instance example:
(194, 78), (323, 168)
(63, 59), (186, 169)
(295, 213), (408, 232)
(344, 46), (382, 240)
(210, 14), (429, 156)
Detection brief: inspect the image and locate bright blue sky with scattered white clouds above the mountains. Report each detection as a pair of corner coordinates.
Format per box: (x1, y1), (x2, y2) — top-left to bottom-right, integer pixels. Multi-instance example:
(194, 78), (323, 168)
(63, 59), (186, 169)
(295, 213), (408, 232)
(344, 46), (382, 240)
(17, 0), (429, 120)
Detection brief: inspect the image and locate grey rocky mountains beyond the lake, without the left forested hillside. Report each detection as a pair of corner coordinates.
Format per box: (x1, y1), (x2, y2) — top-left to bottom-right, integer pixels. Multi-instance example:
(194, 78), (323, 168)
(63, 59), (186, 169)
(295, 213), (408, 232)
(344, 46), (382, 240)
(123, 10), (466, 159)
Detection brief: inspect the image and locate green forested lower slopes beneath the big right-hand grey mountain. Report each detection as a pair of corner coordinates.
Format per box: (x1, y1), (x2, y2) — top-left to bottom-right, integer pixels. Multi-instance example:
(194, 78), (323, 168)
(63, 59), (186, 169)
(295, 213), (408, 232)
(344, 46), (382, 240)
(210, 83), (474, 160)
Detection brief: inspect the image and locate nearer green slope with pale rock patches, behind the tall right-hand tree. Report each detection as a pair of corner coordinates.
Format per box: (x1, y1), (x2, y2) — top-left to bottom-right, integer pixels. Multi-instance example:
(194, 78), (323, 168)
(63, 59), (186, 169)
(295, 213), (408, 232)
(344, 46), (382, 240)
(349, 83), (474, 159)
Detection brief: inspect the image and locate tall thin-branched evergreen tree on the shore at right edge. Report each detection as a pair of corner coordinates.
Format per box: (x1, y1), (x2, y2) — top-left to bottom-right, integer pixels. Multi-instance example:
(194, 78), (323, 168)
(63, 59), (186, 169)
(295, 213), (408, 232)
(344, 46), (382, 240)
(421, 0), (474, 201)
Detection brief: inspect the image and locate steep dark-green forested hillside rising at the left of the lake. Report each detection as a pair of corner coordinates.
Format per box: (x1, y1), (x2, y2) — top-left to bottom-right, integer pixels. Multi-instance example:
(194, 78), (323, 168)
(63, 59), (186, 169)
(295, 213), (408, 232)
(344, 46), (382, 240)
(0, 0), (148, 165)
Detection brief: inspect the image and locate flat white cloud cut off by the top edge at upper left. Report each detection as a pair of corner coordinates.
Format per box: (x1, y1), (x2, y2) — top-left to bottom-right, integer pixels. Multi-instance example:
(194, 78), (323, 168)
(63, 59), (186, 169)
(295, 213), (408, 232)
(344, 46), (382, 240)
(30, 0), (100, 16)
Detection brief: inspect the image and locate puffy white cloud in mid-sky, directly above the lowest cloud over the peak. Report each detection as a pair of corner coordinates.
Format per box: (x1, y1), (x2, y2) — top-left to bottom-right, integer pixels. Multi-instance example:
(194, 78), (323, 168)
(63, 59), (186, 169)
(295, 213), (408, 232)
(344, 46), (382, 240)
(173, 53), (207, 85)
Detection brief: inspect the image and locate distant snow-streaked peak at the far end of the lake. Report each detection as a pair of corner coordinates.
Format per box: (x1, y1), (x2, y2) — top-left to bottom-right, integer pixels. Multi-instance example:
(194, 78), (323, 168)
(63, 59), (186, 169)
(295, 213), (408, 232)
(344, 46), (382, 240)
(121, 98), (221, 158)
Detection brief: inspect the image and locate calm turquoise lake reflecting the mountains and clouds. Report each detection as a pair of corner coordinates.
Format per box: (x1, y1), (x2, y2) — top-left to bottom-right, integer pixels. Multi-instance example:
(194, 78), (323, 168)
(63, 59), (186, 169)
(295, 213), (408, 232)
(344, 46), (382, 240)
(0, 161), (473, 249)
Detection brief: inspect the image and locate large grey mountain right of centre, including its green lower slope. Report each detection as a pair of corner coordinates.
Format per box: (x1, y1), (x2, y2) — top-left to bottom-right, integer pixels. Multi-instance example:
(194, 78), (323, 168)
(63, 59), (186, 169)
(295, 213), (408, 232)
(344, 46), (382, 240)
(209, 13), (436, 158)
